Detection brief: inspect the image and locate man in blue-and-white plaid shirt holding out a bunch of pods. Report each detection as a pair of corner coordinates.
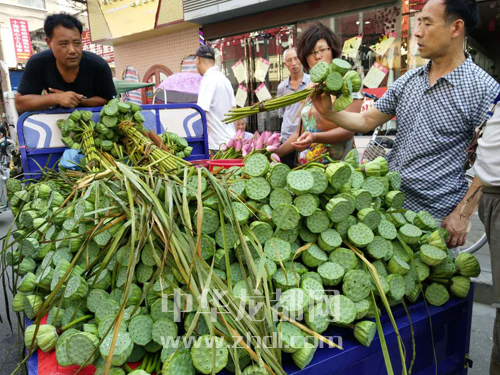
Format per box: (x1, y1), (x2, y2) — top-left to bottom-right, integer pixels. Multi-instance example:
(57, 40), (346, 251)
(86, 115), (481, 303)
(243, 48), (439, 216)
(297, 0), (500, 247)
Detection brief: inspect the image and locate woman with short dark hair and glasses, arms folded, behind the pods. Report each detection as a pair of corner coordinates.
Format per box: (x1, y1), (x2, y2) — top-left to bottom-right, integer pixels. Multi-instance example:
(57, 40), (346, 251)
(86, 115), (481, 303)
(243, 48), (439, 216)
(277, 22), (359, 164)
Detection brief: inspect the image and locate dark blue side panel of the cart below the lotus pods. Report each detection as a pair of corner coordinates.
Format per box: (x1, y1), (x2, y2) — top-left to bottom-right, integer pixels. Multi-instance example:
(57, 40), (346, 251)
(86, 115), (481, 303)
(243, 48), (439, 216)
(28, 284), (474, 375)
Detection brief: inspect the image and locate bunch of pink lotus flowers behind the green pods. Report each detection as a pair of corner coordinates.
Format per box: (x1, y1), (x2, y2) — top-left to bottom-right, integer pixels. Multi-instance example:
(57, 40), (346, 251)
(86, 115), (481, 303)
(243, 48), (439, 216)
(213, 130), (281, 162)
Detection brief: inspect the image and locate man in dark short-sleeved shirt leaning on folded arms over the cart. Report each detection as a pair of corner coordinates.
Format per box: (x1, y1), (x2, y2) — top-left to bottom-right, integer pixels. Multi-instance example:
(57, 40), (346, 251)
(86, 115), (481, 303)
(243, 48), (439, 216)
(16, 13), (116, 112)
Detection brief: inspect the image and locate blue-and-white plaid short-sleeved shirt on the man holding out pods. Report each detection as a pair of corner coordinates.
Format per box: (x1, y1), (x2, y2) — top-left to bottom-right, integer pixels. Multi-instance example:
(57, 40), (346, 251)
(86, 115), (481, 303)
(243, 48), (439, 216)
(375, 54), (500, 218)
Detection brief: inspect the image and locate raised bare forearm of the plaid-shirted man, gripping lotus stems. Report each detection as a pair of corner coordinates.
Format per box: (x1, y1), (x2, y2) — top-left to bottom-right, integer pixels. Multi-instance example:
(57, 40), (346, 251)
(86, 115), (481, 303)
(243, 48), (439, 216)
(312, 94), (394, 136)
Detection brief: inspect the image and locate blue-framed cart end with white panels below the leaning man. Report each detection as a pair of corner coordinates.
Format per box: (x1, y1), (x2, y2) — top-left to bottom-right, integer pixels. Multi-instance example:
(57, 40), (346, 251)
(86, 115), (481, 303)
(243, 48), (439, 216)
(17, 103), (208, 177)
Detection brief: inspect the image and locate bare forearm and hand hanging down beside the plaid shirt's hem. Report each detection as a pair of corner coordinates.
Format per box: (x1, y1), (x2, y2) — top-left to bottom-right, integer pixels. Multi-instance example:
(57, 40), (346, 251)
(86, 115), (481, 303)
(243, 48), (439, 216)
(441, 177), (482, 247)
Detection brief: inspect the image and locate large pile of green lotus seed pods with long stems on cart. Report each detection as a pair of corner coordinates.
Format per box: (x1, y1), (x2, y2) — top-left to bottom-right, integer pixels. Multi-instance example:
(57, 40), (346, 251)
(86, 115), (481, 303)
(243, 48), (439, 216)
(2, 145), (480, 375)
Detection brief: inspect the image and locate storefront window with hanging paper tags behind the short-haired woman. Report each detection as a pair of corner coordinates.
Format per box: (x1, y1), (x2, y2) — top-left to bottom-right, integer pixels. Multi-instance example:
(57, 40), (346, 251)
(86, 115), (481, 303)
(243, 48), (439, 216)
(209, 4), (408, 131)
